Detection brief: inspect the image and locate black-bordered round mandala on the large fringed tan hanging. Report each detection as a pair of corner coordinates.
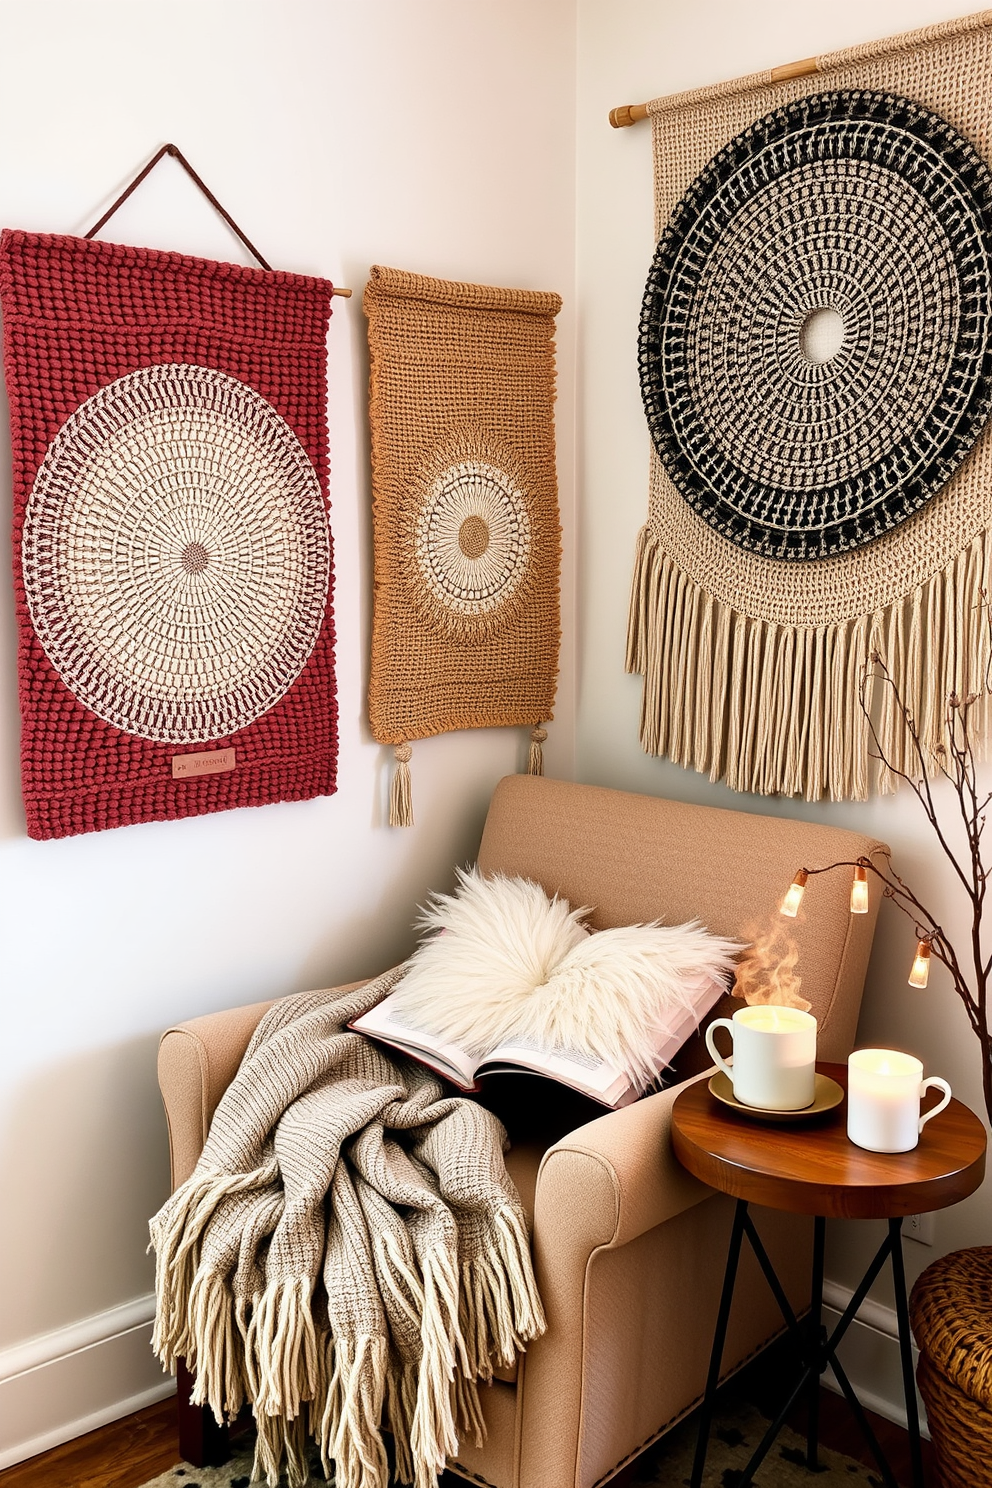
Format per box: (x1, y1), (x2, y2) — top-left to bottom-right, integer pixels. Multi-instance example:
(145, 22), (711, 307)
(640, 92), (992, 559)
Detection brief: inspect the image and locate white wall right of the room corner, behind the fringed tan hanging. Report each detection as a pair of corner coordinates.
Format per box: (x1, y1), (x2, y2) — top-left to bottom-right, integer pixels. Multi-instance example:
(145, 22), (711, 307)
(577, 0), (992, 1415)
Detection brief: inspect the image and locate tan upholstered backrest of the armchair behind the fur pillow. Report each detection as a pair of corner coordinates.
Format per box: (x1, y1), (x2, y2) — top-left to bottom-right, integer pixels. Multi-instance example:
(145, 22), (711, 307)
(479, 775), (883, 1073)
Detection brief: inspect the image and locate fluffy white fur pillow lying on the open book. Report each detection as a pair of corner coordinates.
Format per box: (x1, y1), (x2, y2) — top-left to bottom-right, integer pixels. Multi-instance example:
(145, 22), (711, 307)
(393, 868), (741, 1086)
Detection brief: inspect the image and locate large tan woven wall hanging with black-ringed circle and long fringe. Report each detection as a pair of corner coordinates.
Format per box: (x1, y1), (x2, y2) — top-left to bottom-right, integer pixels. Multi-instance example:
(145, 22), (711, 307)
(628, 12), (992, 799)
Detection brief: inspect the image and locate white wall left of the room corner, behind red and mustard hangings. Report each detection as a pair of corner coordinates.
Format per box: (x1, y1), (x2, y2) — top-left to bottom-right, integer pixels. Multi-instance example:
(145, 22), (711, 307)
(0, 0), (576, 1466)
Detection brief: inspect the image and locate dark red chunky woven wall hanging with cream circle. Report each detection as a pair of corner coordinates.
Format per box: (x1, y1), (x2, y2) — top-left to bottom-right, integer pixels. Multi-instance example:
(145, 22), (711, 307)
(0, 232), (336, 838)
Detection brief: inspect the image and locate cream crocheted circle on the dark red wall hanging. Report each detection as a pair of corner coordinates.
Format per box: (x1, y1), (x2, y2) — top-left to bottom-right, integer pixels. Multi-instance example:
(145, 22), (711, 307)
(22, 365), (330, 744)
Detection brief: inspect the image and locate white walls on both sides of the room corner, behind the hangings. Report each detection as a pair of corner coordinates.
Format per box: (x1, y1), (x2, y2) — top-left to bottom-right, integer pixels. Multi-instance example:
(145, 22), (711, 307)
(0, 0), (991, 1466)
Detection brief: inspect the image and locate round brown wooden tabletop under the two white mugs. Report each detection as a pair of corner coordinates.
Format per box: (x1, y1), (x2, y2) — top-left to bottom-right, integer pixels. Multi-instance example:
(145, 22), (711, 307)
(672, 1064), (986, 1219)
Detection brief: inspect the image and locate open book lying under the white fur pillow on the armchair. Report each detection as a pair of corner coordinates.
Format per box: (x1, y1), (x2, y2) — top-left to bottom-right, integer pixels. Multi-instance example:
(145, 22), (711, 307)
(350, 982), (724, 1110)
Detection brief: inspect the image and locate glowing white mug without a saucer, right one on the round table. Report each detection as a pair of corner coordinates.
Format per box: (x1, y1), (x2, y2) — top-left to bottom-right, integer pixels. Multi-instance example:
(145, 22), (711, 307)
(848, 1049), (950, 1152)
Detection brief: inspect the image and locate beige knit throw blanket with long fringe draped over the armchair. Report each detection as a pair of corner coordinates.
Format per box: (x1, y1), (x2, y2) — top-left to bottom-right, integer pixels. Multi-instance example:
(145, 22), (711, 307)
(150, 967), (544, 1488)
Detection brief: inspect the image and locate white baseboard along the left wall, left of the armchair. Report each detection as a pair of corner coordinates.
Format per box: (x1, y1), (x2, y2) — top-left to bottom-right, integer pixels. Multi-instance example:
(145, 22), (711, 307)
(0, 1295), (178, 1470)
